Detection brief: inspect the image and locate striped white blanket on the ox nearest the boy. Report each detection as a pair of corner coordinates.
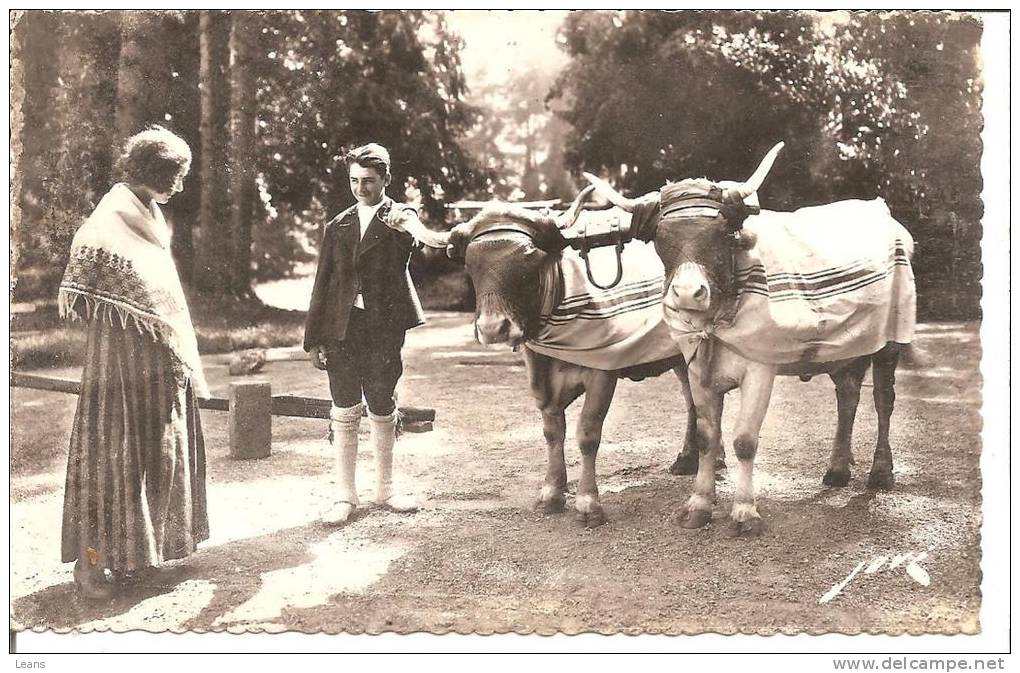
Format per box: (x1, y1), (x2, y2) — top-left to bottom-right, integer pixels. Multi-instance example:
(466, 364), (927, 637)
(525, 241), (681, 370)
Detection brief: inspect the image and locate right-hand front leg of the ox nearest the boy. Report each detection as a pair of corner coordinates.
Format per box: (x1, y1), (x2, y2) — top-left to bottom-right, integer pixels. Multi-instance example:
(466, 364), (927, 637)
(574, 369), (616, 528)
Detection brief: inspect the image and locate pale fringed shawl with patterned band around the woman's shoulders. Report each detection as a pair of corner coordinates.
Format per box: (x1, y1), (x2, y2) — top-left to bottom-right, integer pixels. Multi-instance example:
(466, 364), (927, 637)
(58, 183), (209, 397)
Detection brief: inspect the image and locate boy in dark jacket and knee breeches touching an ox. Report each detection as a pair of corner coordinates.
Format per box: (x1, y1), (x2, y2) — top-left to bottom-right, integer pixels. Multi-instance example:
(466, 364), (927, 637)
(304, 143), (430, 525)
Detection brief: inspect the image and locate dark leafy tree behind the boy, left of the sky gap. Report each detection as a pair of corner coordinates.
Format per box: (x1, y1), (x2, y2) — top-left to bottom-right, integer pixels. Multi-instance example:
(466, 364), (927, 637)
(252, 10), (475, 221)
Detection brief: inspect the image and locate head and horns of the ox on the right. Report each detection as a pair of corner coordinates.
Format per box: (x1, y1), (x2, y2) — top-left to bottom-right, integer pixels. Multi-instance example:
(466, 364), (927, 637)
(585, 143), (783, 326)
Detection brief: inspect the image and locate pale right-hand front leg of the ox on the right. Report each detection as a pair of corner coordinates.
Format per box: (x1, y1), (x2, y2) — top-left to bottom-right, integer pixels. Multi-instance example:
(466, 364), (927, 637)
(727, 366), (775, 537)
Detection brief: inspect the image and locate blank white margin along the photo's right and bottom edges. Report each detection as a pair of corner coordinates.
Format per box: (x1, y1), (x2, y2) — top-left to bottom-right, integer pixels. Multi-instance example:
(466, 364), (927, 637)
(4, 2), (1013, 656)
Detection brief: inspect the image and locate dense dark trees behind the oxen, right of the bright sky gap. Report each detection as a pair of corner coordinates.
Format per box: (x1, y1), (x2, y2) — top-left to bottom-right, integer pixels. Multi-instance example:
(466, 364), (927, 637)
(554, 11), (981, 316)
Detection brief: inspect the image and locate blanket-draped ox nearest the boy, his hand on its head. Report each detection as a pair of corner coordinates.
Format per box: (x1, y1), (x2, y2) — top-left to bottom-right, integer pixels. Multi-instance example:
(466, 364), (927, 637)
(432, 188), (697, 527)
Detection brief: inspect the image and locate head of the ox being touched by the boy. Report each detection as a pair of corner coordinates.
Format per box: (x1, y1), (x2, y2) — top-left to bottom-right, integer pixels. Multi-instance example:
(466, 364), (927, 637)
(448, 188), (593, 347)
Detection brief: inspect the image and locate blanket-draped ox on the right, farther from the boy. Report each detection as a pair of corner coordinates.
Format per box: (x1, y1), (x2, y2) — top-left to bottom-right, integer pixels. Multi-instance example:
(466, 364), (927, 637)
(585, 143), (916, 536)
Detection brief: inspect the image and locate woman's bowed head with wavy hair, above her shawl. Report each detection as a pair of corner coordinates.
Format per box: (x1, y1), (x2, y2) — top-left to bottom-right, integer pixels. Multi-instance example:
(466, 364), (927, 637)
(116, 125), (191, 193)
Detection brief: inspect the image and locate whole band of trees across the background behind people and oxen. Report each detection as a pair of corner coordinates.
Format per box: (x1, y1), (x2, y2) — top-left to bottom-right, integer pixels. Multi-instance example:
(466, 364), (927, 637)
(12, 10), (981, 315)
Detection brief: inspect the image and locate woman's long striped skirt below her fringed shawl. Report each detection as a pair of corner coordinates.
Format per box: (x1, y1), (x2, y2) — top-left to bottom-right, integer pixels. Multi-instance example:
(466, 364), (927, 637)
(61, 318), (209, 571)
